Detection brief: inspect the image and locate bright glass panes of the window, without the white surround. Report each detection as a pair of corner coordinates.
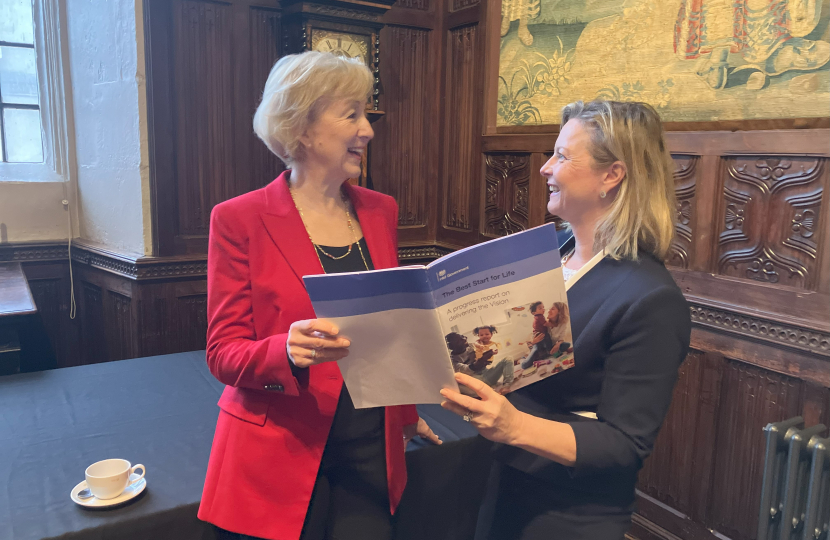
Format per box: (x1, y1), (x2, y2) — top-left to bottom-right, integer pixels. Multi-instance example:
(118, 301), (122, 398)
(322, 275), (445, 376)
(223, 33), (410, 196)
(0, 0), (43, 163)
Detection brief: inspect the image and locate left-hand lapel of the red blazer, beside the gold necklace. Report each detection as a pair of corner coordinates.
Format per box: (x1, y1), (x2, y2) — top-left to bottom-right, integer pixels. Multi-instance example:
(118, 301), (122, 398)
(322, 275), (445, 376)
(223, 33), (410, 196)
(260, 170), (324, 282)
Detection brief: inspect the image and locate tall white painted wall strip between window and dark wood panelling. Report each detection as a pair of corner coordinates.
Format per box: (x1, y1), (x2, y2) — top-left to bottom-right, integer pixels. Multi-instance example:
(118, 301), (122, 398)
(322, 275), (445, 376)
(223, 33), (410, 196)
(66, 0), (152, 255)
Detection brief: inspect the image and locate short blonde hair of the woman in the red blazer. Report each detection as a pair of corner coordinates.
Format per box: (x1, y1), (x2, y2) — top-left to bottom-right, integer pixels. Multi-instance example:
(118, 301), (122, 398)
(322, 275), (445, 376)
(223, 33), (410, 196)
(254, 51), (374, 166)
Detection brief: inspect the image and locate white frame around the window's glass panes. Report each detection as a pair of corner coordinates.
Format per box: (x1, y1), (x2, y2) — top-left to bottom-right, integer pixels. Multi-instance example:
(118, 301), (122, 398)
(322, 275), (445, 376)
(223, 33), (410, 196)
(0, 0), (75, 184)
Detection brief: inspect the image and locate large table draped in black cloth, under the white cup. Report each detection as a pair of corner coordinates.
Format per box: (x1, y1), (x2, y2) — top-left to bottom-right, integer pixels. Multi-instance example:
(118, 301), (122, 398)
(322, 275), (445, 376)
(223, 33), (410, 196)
(0, 351), (490, 540)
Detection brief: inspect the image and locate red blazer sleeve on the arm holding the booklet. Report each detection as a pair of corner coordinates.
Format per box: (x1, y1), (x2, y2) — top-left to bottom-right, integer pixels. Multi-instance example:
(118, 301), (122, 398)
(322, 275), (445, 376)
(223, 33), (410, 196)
(207, 205), (299, 396)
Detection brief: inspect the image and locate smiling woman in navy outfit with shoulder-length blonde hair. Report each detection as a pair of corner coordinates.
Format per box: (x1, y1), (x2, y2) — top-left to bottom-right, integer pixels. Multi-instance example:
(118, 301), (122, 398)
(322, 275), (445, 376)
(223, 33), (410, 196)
(442, 101), (691, 540)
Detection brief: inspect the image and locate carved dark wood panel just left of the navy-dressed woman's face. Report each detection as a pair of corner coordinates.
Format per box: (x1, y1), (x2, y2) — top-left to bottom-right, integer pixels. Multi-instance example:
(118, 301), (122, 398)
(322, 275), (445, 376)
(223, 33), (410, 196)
(484, 154), (530, 237)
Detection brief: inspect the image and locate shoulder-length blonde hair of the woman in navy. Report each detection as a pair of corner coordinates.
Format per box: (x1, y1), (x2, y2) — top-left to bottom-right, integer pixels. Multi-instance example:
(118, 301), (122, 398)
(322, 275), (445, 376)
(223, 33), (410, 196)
(561, 101), (676, 261)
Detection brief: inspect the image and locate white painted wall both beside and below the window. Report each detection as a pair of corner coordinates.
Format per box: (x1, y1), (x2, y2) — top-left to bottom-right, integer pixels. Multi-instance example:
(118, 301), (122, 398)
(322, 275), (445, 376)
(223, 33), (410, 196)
(0, 0), (152, 255)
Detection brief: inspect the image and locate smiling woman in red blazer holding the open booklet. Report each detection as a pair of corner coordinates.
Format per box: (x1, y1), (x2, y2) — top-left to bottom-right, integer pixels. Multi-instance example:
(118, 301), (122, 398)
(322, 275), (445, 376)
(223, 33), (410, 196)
(199, 52), (438, 540)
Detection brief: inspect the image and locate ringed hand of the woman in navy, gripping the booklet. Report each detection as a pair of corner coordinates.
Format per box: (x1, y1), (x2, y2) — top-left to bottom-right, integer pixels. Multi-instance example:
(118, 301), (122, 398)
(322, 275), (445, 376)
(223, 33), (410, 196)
(441, 373), (524, 444)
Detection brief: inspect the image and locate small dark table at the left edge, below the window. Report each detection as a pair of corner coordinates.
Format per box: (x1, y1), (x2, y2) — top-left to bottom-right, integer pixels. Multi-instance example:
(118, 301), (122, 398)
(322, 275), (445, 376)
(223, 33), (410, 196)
(0, 263), (37, 375)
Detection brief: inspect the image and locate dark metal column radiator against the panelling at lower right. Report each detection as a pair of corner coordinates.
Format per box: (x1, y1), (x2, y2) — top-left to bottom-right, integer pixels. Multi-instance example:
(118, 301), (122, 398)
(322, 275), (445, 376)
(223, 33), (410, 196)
(757, 416), (830, 540)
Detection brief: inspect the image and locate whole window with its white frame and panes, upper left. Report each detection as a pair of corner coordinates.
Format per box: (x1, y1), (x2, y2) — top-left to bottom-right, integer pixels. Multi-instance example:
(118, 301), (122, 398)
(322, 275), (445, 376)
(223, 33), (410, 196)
(0, 0), (74, 182)
